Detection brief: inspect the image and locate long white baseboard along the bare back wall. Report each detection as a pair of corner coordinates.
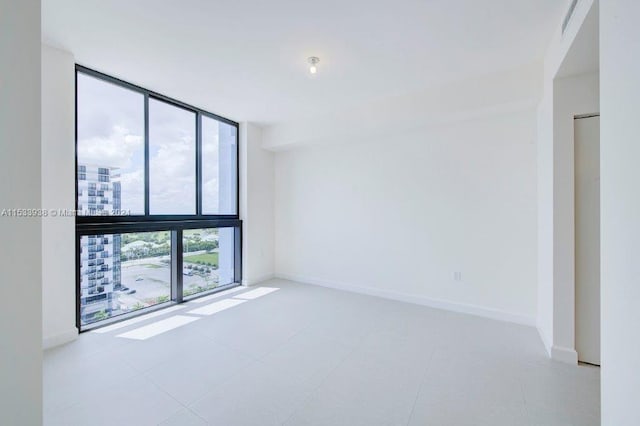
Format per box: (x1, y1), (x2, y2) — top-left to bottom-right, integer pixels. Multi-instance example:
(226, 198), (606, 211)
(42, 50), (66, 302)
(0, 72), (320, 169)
(275, 272), (536, 327)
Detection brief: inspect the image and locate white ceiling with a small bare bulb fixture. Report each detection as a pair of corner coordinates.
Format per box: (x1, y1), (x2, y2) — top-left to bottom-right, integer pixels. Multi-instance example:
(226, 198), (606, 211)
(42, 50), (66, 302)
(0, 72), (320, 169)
(42, 0), (567, 124)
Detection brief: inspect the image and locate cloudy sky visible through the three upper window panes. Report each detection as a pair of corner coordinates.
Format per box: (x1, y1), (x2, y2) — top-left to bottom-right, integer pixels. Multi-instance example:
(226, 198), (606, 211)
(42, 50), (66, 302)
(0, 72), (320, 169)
(78, 73), (235, 214)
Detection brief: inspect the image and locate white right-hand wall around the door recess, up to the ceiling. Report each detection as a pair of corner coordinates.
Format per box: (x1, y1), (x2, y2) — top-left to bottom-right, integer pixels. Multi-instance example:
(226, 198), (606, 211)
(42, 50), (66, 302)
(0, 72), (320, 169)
(537, 0), (599, 364)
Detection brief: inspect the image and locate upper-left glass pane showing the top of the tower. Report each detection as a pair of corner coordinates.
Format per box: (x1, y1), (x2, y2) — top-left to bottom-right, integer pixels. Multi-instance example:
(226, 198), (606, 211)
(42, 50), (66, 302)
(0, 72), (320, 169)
(77, 73), (144, 216)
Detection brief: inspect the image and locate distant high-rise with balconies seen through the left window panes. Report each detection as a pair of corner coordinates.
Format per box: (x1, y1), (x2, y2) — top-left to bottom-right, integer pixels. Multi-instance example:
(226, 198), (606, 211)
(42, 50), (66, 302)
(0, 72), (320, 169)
(78, 165), (122, 323)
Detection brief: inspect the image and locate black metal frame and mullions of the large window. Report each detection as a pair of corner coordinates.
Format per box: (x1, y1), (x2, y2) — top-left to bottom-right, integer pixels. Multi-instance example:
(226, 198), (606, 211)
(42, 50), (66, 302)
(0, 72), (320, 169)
(74, 64), (242, 332)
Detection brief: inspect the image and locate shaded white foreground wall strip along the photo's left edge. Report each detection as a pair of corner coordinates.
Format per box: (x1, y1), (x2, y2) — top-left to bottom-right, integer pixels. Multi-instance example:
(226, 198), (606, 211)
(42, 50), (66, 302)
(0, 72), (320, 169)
(0, 0), (42, 425)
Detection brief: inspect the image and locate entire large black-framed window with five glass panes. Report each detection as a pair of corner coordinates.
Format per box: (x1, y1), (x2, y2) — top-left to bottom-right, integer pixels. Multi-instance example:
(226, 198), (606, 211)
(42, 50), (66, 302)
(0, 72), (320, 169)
(76, 66), (241, 330)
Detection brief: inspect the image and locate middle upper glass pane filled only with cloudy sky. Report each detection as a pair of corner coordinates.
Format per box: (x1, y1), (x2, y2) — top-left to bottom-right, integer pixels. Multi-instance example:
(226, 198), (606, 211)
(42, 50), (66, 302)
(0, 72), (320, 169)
(149, 99), (196, 214)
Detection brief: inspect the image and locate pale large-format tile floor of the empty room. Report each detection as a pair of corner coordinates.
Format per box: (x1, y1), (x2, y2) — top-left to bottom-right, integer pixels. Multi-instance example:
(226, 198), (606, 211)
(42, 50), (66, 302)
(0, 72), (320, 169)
(44, 280), (600, 426)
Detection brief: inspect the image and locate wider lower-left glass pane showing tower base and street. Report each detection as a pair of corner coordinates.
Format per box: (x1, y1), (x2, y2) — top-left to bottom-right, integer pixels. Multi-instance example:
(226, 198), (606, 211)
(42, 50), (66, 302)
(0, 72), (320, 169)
(80, 231), (171, 325)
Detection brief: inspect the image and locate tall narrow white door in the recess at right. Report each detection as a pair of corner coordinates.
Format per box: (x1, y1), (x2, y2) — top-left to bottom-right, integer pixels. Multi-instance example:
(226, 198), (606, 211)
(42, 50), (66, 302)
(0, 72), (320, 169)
(574, 117), (600, 365)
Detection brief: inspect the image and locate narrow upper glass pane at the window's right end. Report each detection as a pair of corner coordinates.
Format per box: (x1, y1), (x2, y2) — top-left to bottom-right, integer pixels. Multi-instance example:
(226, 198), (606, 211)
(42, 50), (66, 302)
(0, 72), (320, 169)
(202, 116), (238, 214)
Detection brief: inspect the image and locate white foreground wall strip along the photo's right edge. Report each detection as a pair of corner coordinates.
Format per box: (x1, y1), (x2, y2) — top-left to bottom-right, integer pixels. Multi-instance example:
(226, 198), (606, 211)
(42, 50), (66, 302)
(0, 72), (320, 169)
(600, 0), (640, 426)
